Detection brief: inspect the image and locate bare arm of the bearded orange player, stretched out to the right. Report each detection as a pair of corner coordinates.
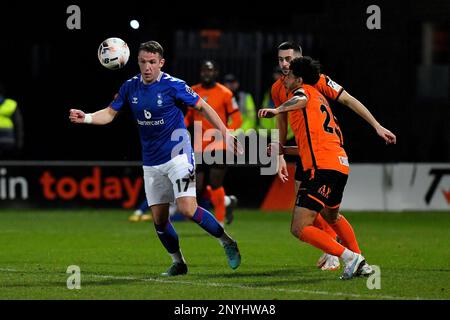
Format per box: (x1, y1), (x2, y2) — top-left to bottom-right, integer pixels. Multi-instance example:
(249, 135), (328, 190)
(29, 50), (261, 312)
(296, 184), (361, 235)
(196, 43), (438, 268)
(337, 90), (397, 144)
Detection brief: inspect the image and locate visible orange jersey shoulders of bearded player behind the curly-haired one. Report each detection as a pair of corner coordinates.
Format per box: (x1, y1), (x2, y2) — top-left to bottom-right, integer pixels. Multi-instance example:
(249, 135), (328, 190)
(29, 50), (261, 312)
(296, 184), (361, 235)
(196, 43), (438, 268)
(271, 74), (344, 107)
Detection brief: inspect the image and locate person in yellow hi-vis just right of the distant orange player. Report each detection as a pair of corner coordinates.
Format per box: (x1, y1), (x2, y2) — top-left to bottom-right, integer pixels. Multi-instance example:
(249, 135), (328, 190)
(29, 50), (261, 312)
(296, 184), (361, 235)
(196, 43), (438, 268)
(223, 73), (257, 134)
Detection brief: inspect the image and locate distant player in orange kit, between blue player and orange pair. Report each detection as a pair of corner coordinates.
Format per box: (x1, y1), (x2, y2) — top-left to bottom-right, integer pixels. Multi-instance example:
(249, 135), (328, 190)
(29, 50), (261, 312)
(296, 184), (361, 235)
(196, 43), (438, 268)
(184, 60), (242, 226)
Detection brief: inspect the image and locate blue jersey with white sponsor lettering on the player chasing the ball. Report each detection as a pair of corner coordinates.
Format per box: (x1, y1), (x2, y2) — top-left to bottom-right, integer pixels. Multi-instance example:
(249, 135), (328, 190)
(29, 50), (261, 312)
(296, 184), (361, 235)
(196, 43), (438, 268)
(111, 72), (200, 166)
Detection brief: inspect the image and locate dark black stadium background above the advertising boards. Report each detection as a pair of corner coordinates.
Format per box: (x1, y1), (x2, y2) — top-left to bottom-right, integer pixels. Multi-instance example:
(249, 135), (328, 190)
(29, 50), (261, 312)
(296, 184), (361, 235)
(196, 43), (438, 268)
(0, 0), (450, 205)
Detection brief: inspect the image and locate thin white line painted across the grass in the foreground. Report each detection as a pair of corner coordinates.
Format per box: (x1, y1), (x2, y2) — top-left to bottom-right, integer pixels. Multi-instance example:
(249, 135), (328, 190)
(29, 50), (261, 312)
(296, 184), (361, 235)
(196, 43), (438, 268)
(0, 268), (425, 300)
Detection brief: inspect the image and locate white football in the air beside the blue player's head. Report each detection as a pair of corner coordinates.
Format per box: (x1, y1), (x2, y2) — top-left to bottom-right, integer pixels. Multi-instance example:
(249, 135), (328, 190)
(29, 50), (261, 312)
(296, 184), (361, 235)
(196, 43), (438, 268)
(98, 38), (130, 70)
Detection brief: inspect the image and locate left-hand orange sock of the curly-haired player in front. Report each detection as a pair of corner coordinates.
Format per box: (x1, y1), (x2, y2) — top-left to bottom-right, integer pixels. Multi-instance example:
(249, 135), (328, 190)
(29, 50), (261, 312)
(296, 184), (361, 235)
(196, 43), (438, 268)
(299, 226), (345, 257)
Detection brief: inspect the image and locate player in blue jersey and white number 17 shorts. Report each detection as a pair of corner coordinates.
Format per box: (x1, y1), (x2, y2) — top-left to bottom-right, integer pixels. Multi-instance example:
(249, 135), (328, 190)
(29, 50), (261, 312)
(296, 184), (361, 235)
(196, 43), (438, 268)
(69, 41), (243, 276)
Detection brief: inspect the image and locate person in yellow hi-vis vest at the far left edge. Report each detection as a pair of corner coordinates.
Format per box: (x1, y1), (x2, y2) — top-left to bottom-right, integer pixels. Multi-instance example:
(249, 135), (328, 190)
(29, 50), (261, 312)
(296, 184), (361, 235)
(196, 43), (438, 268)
(0, 83), (23, 159)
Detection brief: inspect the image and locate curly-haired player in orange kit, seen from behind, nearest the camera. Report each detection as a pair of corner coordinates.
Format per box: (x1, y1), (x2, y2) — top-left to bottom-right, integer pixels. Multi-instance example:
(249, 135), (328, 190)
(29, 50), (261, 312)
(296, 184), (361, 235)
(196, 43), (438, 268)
(258, 57), (396, 279)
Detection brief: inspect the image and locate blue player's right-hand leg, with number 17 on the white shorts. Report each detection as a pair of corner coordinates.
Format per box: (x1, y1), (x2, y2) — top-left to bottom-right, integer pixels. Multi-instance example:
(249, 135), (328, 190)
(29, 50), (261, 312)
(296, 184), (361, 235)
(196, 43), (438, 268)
(166, 155), (241, 269)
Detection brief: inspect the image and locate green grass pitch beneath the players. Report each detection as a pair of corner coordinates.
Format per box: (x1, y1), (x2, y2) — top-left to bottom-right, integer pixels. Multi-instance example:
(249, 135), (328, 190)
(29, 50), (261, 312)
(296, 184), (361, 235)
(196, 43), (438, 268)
(0, 209), (450, 300)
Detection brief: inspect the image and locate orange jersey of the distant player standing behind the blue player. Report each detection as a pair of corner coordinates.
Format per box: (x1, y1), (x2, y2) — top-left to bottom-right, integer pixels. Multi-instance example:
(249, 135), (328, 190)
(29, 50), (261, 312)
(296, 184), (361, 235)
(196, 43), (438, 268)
(185, 83), (239, 152)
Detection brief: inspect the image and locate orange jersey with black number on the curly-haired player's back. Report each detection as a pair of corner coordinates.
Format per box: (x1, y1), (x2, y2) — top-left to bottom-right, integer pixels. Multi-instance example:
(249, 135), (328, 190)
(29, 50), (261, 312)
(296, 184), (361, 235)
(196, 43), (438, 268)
(288, 84), (349, 174)
